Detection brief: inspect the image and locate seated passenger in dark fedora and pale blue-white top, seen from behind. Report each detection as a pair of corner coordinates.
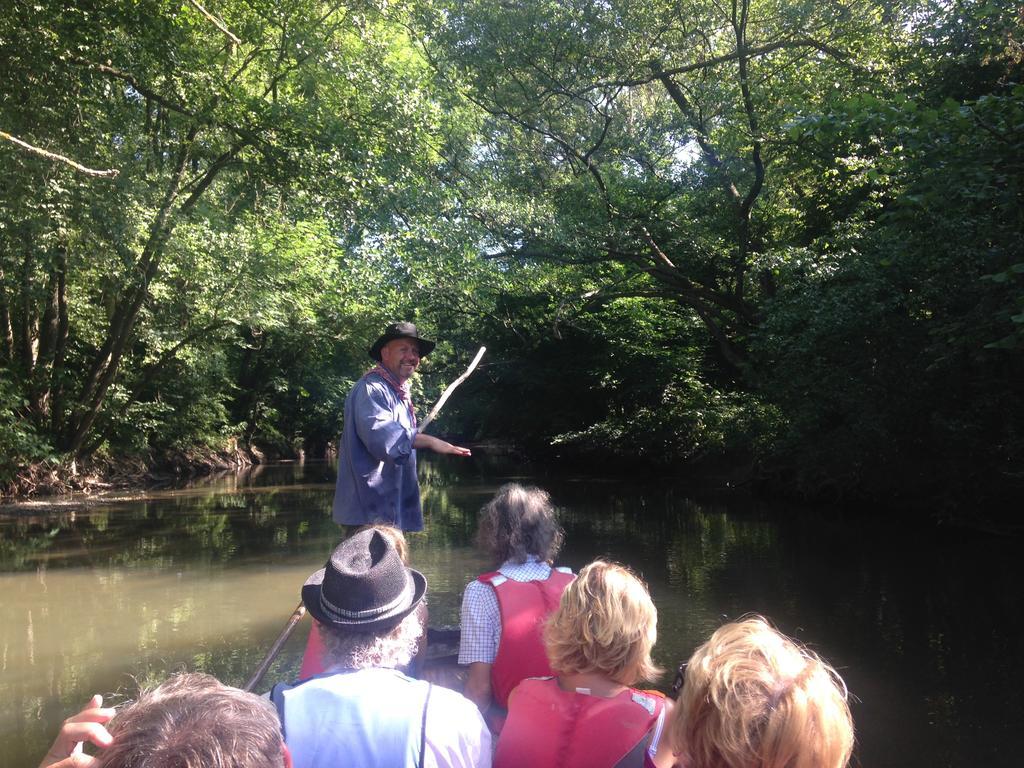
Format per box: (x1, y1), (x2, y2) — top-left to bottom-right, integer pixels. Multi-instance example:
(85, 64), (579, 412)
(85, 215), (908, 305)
(270, 528), (490, 768)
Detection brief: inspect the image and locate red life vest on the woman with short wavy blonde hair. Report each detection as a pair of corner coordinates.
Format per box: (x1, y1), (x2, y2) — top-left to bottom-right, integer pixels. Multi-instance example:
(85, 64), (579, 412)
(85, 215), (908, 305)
(494, 678), (665, 768)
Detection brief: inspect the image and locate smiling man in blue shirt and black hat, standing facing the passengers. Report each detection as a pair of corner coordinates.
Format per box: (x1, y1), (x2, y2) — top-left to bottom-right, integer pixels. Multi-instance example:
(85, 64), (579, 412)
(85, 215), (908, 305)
(334, 323), (470, 530)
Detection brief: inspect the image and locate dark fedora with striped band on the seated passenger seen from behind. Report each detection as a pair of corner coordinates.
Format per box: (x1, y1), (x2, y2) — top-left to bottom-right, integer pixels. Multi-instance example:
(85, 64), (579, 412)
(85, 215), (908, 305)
(302, 528), (427, 632)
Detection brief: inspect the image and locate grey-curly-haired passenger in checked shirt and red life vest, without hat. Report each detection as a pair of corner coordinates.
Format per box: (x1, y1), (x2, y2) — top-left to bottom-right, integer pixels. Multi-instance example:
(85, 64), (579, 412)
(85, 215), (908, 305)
(459, 482), (572, 733)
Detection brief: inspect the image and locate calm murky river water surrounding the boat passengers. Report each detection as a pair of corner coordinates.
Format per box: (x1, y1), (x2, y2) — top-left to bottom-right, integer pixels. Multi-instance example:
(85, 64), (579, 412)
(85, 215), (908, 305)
(0, 458), (1024, 768)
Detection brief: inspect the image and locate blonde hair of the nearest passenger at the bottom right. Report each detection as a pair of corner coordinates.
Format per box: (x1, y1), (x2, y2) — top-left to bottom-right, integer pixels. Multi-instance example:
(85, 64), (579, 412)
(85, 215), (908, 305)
(670, 616), (853, 768)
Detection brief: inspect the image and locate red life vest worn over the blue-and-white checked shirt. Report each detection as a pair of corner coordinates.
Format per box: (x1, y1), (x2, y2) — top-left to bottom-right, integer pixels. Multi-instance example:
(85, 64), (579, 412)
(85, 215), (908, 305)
(478, 568), (574, 709)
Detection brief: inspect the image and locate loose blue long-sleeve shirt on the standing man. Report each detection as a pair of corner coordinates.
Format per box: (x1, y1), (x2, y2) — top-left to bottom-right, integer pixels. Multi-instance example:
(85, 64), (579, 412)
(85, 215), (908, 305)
(334, 371), (423, 530)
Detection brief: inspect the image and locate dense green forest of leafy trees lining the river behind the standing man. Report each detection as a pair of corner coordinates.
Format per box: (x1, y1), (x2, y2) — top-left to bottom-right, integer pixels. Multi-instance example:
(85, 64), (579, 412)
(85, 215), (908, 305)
(0, 0), (1024, 514)
